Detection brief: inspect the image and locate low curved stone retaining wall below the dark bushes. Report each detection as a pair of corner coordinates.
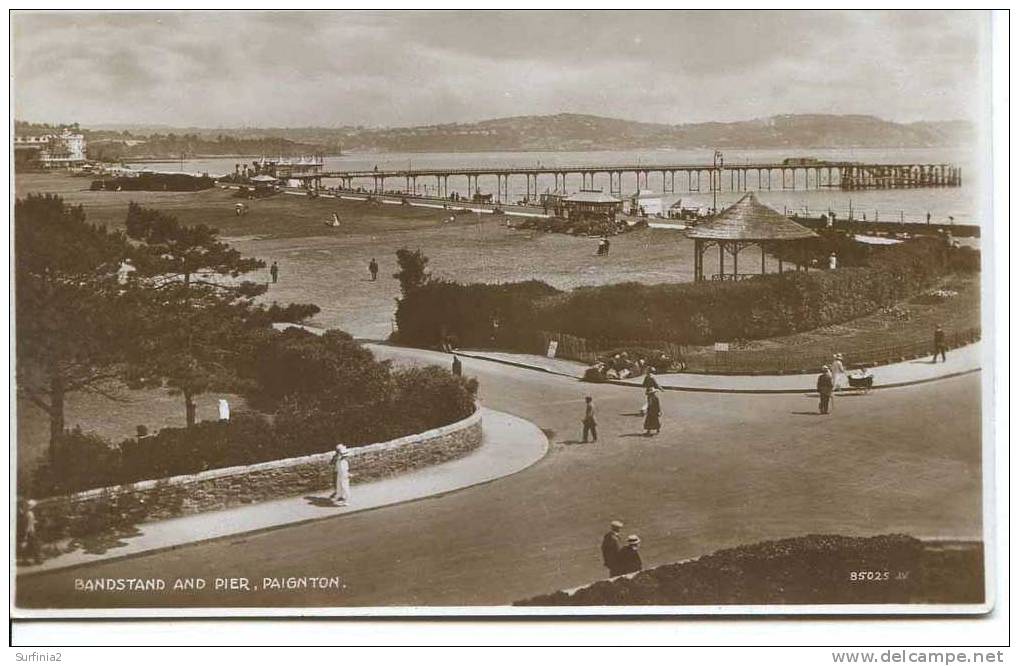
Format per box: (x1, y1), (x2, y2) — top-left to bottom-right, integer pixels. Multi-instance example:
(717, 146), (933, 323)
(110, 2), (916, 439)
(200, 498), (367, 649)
(29, 407), (482, 542)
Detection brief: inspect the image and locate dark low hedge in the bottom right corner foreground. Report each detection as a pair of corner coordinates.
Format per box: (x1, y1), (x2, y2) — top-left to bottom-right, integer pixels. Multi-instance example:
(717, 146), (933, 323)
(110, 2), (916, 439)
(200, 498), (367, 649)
(515, 535), (983, 606)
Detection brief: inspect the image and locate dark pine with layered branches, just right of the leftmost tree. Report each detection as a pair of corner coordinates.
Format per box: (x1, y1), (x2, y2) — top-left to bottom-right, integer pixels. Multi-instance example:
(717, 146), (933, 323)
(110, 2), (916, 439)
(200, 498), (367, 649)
(126, 203), (267, 428)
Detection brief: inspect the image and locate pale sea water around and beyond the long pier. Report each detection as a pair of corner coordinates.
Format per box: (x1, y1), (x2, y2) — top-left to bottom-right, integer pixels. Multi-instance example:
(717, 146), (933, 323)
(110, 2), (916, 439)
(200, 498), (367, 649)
(131, 148), (989, 224)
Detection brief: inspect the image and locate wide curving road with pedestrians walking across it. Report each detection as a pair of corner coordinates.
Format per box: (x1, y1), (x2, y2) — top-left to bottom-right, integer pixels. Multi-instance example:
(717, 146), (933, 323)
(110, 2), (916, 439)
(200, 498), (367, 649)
(9, 346), (982, 608)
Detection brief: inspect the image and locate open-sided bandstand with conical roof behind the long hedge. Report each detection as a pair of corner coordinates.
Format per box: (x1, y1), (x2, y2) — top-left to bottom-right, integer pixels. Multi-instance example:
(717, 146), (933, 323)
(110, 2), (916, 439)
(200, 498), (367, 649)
(687, 192), (817, 282)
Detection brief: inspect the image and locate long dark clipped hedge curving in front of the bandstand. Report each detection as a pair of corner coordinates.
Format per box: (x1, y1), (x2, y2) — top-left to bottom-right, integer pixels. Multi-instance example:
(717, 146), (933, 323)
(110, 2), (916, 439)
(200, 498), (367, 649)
(396, 238), (973, 350)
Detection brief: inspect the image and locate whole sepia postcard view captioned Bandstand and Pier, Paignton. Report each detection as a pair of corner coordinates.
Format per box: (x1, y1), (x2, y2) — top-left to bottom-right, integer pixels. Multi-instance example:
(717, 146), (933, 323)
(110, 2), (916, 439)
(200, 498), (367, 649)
(9, 9), (1008, 619)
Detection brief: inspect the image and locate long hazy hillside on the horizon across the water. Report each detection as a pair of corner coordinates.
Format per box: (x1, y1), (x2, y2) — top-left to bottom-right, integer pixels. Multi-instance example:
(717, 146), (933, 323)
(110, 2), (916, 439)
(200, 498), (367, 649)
(31, 113), (973, 159)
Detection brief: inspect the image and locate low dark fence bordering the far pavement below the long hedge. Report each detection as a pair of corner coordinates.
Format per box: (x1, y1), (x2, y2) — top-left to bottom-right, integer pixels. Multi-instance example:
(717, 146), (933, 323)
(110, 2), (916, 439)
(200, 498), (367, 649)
(540, 328), (980, 375)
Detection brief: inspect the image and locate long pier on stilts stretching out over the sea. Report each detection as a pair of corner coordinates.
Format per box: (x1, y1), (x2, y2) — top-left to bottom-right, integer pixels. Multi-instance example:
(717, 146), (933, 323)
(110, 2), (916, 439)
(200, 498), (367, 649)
(290, 160), (962, 203)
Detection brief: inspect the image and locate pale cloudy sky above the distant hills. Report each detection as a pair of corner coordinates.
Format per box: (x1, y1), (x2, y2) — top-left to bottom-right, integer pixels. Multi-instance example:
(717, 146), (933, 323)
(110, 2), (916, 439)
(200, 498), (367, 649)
(11, 10), (989, 127)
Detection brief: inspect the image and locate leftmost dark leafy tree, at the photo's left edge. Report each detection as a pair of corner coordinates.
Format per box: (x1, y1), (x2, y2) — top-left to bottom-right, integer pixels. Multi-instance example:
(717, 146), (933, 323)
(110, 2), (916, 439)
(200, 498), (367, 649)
(14, 195), (130, 453)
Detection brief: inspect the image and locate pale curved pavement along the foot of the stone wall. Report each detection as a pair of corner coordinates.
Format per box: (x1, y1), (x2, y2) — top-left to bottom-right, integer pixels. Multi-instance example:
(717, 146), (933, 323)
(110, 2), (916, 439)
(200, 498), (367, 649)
(18, 407), (548, 575)
